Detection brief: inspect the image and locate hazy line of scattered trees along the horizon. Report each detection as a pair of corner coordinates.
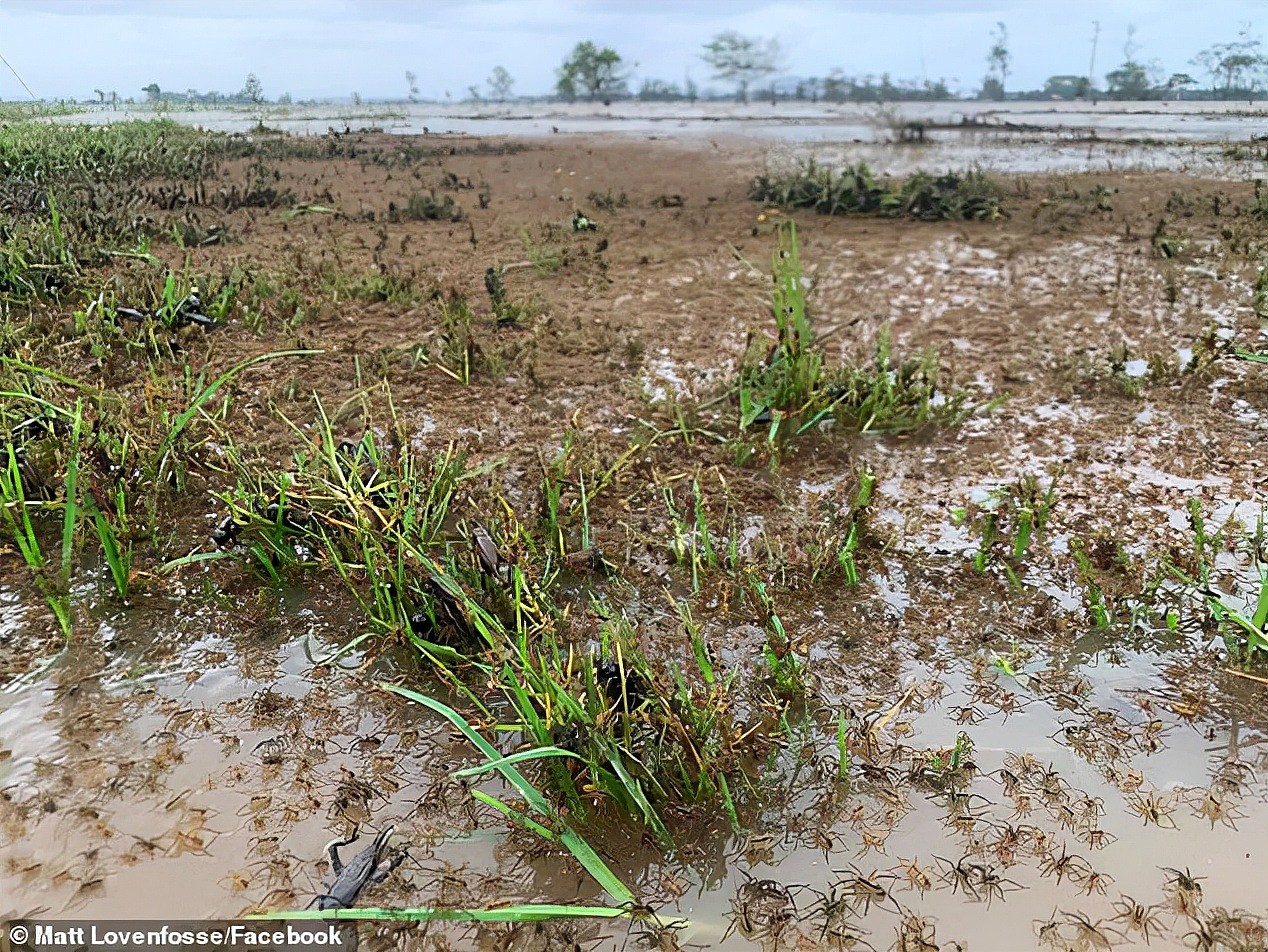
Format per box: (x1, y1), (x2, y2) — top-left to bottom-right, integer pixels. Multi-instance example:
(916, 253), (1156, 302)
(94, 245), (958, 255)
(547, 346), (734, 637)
(94, 22), (1268, 105)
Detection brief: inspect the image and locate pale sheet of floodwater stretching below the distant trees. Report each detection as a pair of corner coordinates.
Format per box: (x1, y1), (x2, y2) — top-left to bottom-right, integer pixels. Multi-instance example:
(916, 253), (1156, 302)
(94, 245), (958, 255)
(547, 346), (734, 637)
(65, 101), (1265, 175)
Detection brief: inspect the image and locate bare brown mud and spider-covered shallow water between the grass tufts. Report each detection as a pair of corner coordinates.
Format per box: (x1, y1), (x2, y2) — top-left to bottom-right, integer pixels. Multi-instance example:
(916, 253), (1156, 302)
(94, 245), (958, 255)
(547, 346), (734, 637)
(0, 128), (1268, 952)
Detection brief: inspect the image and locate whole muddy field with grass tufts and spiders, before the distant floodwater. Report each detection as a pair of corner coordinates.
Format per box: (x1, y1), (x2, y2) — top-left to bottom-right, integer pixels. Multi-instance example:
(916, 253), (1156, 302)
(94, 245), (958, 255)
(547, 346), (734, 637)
(0, 115), (1268, 952)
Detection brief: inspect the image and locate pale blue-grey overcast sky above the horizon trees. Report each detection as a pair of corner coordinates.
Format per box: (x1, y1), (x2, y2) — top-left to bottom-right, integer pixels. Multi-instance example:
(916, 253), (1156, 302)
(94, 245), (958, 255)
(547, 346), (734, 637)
(0, 0), (1268, 99)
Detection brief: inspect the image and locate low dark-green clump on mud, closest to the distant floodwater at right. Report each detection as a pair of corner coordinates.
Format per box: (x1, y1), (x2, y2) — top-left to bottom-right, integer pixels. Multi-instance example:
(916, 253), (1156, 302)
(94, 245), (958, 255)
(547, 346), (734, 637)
(749, 160), (1004, 221)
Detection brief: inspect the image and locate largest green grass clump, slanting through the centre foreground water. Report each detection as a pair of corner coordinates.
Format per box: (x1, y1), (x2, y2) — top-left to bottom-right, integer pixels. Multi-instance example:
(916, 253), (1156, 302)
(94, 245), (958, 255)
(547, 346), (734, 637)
(213, 404), (752, 840)
